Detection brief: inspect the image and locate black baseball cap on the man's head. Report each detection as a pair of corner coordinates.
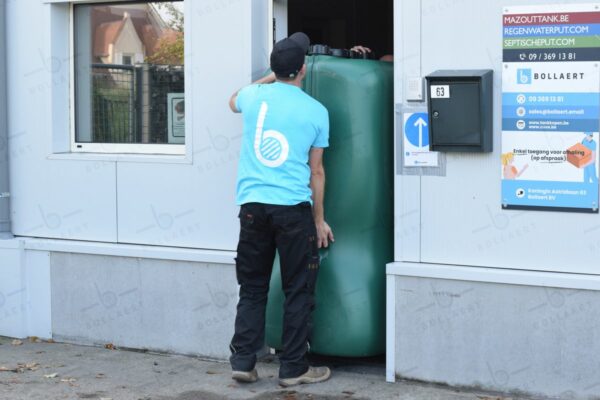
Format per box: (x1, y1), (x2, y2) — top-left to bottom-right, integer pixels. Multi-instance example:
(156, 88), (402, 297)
(271, 32), (310, 78)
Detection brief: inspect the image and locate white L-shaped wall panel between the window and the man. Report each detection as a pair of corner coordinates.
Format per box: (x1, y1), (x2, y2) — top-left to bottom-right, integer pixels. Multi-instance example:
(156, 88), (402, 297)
(117, 1), (266, 250)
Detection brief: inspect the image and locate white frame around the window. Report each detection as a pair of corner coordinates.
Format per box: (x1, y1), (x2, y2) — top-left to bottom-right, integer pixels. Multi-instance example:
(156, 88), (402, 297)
(68, 0), (186, 156)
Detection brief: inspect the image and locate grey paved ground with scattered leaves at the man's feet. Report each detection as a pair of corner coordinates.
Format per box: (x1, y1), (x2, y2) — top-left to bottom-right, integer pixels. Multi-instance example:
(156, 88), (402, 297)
(0, 337), (524, 400)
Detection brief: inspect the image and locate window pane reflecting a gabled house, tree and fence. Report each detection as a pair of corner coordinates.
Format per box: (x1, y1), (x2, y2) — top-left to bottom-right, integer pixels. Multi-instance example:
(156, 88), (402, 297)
(74, 1), (185, 144)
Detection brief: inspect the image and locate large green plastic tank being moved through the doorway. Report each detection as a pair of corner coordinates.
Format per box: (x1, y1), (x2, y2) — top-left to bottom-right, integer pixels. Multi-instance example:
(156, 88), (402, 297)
(266, 56), (394, 357)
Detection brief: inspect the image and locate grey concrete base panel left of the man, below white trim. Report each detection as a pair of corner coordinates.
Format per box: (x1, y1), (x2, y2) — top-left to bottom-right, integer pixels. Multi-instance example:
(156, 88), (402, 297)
(51, 253), (238, 359)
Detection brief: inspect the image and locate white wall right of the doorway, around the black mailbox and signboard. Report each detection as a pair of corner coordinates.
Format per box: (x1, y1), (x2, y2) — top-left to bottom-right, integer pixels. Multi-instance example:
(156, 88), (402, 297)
(395, 0), (600, 274)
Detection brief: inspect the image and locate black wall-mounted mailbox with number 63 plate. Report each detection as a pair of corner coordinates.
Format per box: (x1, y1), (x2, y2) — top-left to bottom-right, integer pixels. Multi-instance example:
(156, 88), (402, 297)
(426, 69), (494, 153)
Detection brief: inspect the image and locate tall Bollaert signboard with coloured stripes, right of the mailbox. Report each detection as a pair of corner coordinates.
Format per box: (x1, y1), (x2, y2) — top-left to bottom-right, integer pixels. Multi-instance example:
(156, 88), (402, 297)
(500, 4), (600, 213)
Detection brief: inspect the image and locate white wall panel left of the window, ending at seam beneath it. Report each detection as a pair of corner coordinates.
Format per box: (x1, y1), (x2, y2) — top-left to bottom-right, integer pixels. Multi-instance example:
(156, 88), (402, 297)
(6, 0), (116, 241)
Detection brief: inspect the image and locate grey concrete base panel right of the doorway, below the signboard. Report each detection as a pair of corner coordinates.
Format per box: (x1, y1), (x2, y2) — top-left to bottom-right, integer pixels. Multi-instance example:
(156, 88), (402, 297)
(394, 276), (600, 399)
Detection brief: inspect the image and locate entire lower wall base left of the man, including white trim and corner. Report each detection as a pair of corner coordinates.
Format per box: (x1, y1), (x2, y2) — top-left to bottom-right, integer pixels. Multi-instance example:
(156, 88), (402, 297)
(0, 239), (238, 359)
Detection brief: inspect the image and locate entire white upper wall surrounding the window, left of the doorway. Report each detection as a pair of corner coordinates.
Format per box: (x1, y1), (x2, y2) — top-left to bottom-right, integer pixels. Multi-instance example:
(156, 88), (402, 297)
(7, 0), (267, 250)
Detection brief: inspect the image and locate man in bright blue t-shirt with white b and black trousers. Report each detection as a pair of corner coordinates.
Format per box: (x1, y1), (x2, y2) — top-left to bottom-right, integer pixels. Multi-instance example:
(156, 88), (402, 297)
(229, 33), (334, 386)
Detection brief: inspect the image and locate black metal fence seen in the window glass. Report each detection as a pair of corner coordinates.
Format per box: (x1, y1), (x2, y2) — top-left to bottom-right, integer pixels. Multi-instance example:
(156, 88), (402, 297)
(92, 64), (185, 143)
